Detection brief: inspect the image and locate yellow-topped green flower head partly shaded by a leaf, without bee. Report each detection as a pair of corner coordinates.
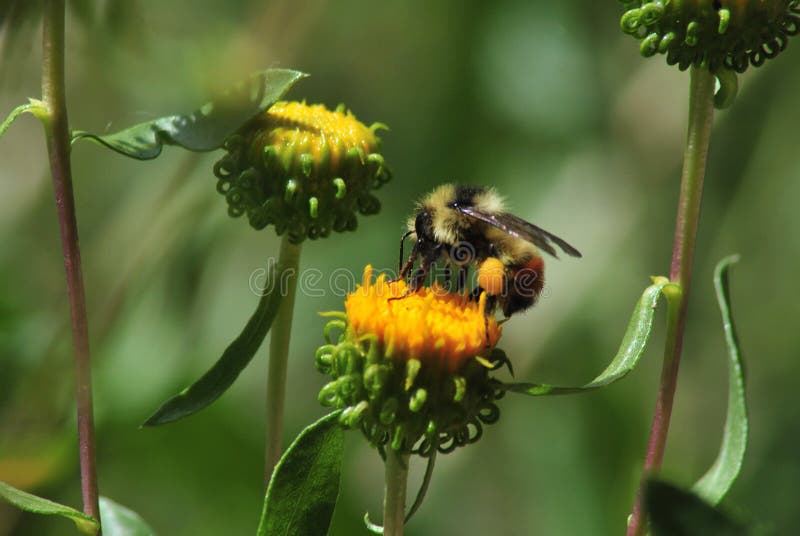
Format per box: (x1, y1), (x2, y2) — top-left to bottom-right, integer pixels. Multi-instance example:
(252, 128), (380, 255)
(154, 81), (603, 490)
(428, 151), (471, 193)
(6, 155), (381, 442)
(214, 102), (391, 243)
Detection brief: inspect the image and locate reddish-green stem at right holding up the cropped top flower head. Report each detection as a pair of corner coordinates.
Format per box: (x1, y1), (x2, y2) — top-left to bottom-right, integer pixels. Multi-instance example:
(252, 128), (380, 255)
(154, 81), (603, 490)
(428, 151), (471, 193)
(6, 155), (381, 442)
(626, 67), (715, 536)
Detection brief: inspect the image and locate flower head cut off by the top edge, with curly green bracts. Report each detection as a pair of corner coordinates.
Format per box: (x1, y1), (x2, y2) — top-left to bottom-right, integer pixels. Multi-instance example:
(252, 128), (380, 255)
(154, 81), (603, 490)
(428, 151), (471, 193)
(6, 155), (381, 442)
(620, 0), (800, 73)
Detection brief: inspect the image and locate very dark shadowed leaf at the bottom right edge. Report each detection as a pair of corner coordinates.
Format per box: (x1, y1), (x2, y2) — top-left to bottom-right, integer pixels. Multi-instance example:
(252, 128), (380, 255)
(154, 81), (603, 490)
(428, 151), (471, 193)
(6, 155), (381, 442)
(644, 480), (748, 536)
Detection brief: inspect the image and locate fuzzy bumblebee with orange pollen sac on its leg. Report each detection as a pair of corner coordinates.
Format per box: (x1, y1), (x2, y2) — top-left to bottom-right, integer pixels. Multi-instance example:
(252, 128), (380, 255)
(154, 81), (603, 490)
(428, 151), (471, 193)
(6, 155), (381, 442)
(399, 184), (581, 317)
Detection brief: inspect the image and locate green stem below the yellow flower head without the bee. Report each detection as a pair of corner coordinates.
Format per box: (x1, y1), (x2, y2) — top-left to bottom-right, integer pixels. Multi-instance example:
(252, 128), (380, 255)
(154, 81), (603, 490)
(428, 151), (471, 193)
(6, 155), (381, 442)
(264, 235), (300, 486)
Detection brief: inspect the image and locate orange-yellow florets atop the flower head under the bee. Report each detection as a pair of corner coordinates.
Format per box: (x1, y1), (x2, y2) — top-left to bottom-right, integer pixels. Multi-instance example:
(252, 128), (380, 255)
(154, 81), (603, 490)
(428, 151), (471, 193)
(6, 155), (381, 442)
(345, 266), (501, 372)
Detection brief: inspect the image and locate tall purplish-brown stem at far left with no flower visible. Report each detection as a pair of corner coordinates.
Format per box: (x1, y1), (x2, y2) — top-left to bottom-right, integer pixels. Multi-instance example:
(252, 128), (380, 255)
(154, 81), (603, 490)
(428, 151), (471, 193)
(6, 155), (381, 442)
(40, 0), (100, 522)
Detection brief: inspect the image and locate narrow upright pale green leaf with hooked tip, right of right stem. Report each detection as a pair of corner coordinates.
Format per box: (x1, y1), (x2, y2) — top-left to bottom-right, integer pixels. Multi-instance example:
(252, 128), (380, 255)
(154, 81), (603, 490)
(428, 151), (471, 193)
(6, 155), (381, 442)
(692, 255), (748, 504)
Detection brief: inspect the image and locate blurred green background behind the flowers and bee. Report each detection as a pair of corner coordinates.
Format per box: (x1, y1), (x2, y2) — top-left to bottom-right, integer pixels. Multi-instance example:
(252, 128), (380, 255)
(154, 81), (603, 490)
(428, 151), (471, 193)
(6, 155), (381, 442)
(0, 0), (800, 536)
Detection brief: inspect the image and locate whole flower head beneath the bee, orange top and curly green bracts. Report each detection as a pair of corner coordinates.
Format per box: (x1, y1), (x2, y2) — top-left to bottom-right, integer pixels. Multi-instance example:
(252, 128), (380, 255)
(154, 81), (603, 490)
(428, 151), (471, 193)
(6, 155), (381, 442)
(315, 267), (506, 456)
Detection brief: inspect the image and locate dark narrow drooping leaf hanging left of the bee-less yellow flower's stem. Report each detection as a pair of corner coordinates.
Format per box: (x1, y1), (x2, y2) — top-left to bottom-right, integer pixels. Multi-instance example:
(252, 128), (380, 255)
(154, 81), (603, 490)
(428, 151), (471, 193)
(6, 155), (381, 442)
(143, 266), (282, 426)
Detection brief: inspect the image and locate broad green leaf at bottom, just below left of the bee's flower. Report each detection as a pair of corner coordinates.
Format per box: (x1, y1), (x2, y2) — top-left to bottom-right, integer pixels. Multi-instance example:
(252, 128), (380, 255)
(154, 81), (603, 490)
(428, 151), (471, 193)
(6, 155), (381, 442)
(258, 411), (344, 536)
